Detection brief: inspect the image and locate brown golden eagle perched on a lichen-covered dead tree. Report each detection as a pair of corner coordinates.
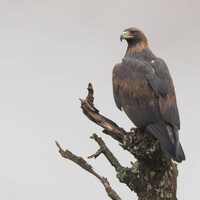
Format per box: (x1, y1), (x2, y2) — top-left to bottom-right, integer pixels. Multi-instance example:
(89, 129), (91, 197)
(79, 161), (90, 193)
(112, 28), (185, 162)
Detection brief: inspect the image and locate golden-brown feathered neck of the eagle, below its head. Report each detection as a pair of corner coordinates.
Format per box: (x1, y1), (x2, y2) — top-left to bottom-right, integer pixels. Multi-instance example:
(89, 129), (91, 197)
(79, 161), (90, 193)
(125, 41), (149, 56)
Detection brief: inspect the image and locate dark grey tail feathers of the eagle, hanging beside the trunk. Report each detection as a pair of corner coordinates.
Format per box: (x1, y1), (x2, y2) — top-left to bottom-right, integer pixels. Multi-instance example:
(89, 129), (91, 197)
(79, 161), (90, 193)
(146, 122), (185, 162)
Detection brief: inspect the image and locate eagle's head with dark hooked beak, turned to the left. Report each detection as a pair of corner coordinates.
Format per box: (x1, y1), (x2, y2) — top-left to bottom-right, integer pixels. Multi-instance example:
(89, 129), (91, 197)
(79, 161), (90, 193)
(120, 28), (147, 45)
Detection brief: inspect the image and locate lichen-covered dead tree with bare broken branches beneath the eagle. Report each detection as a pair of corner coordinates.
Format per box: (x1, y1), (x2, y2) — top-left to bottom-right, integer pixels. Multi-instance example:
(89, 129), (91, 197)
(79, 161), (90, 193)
(56, 84), (178, 200)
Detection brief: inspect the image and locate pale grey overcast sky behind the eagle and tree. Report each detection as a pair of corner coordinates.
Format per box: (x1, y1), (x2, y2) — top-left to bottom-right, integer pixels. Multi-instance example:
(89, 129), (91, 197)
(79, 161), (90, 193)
(0, 0), (200, 200)
